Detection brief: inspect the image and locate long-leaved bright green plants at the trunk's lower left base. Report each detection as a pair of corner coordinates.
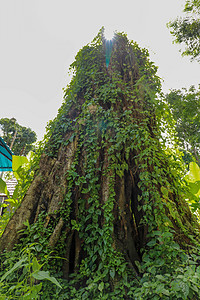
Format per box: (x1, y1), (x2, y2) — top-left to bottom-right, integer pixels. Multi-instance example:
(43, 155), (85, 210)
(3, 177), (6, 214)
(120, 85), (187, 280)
(0, 243), (62, 300)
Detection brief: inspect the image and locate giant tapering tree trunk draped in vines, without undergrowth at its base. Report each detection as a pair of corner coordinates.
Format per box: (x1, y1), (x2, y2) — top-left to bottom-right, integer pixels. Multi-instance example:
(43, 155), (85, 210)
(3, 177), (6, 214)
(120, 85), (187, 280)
(0, 29), (199, 296)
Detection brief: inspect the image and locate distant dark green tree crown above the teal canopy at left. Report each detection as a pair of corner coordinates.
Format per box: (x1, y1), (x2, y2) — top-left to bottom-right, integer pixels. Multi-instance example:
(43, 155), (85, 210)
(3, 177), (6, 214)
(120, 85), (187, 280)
(0, 118), (37, 155)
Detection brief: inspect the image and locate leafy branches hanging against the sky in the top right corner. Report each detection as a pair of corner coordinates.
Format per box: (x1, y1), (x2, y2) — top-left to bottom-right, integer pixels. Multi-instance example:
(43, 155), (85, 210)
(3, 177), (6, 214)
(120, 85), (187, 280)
(168, 0), (200, 61)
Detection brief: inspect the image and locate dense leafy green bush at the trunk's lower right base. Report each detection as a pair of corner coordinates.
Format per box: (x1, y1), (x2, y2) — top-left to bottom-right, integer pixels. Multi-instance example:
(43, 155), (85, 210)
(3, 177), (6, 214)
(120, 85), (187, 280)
(128, 231), (200, 300)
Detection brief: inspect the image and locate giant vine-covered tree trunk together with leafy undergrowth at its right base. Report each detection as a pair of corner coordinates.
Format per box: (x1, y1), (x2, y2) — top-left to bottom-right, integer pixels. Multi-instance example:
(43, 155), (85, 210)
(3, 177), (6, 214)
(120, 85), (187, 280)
(0, 31), (200, 300)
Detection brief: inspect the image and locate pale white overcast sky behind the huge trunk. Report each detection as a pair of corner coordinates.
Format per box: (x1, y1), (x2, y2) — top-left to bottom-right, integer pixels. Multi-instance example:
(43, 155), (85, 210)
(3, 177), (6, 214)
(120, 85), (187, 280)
(0, 0), (200, 139)
